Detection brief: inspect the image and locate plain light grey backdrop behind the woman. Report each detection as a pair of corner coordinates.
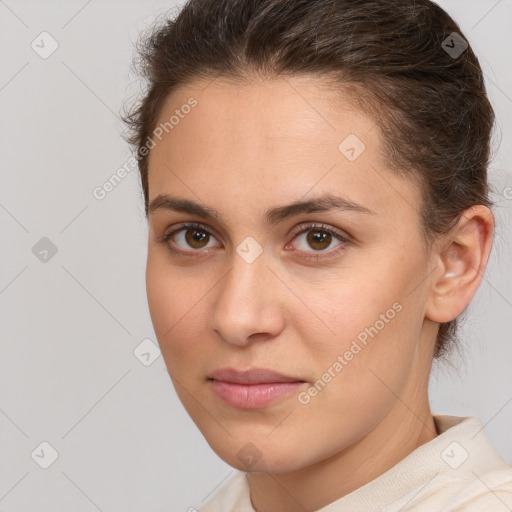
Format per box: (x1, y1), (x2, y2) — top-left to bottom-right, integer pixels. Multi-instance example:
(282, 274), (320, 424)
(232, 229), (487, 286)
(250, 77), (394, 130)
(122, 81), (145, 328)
(0, 0), (512, 512)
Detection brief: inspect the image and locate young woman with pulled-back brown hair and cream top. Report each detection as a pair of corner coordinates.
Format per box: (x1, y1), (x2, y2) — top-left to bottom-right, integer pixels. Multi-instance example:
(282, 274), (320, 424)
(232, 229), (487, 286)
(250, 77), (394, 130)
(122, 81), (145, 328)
(126, 0), (512, 512)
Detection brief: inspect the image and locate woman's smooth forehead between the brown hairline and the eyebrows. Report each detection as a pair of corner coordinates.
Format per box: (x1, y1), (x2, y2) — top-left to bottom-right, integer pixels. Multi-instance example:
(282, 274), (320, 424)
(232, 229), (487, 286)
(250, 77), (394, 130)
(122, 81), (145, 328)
(149, 77), (419, 222)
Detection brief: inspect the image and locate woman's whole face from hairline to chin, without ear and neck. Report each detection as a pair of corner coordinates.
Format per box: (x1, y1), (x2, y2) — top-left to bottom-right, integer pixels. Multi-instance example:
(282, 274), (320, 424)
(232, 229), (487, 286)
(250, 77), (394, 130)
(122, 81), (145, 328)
(146, 77), (435, 472)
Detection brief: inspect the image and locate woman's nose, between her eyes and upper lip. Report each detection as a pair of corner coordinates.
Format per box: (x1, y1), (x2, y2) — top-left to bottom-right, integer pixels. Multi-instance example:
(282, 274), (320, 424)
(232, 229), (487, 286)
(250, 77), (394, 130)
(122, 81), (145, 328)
(211, 248), (286, 346)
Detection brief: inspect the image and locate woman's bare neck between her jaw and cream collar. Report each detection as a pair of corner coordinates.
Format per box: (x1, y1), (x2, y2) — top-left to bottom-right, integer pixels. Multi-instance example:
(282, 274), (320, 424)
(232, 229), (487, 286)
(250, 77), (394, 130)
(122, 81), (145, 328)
(248, 368), (437, 512)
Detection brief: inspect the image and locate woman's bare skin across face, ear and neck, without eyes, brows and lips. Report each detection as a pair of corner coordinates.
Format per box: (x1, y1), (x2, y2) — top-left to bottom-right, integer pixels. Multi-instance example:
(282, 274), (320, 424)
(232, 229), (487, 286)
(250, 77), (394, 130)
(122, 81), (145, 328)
(146, 76), (493, 512)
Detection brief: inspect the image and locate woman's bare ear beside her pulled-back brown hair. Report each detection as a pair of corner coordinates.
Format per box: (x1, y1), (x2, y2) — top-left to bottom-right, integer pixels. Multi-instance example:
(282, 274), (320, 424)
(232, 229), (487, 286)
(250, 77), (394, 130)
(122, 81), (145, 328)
(425, 205), (494, 323)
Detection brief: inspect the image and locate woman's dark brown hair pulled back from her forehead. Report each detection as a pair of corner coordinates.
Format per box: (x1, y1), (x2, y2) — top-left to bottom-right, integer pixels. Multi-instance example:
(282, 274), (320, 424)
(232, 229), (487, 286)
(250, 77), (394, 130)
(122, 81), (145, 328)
(123, 0), (494, 358)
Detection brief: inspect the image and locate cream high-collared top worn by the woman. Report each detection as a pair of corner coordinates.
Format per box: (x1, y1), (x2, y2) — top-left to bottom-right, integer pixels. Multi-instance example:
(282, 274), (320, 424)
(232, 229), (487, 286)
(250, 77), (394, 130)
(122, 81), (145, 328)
(199, 415), (512, 512)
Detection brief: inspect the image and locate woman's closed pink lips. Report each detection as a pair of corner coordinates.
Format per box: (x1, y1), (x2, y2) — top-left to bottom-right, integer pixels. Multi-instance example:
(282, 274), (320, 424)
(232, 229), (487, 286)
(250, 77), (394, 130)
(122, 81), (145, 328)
(208, 368), (306, 409)
